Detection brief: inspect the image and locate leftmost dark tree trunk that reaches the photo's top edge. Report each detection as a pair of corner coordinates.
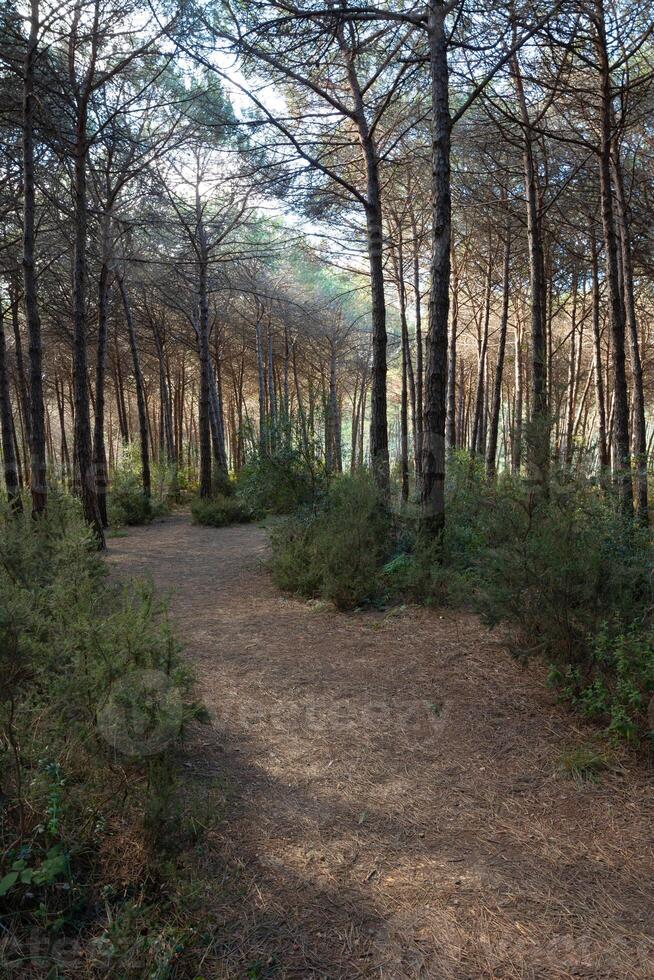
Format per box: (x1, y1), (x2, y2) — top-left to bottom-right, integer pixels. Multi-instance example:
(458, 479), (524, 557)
(23, 0), (48, 514)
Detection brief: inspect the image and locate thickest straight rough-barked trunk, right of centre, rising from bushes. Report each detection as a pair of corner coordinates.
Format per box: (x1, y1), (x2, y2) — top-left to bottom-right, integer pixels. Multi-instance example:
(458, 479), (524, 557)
(421, 0), (452, 534)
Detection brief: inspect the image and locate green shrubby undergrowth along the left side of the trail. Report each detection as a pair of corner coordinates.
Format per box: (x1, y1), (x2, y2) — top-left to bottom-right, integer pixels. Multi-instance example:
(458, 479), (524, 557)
(0, 502), (220, 978)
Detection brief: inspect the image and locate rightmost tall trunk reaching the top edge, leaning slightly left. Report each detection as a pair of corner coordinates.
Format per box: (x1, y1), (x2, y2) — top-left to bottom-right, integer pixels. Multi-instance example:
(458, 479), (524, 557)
(593, 0), (633, 515)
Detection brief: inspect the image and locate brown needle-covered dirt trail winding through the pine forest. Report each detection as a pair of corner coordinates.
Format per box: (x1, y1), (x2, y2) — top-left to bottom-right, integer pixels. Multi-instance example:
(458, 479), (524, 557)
(109, 515), (654, 980)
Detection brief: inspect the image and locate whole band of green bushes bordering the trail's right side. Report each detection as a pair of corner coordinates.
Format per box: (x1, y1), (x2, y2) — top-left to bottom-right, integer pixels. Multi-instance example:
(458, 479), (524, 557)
(272, 454), (654, 743)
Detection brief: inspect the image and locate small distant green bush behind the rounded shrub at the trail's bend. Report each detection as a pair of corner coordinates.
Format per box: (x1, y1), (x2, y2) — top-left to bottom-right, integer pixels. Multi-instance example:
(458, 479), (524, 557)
(236, 448), (325, 514)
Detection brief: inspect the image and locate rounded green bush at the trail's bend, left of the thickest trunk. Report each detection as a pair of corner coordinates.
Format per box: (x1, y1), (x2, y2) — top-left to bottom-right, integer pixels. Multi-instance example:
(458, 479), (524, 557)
(272, 473), (391, 609)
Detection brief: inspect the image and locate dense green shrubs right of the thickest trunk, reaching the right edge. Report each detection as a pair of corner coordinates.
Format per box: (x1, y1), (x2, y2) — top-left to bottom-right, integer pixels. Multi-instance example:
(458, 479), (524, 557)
(384, 454), (654, 741)
